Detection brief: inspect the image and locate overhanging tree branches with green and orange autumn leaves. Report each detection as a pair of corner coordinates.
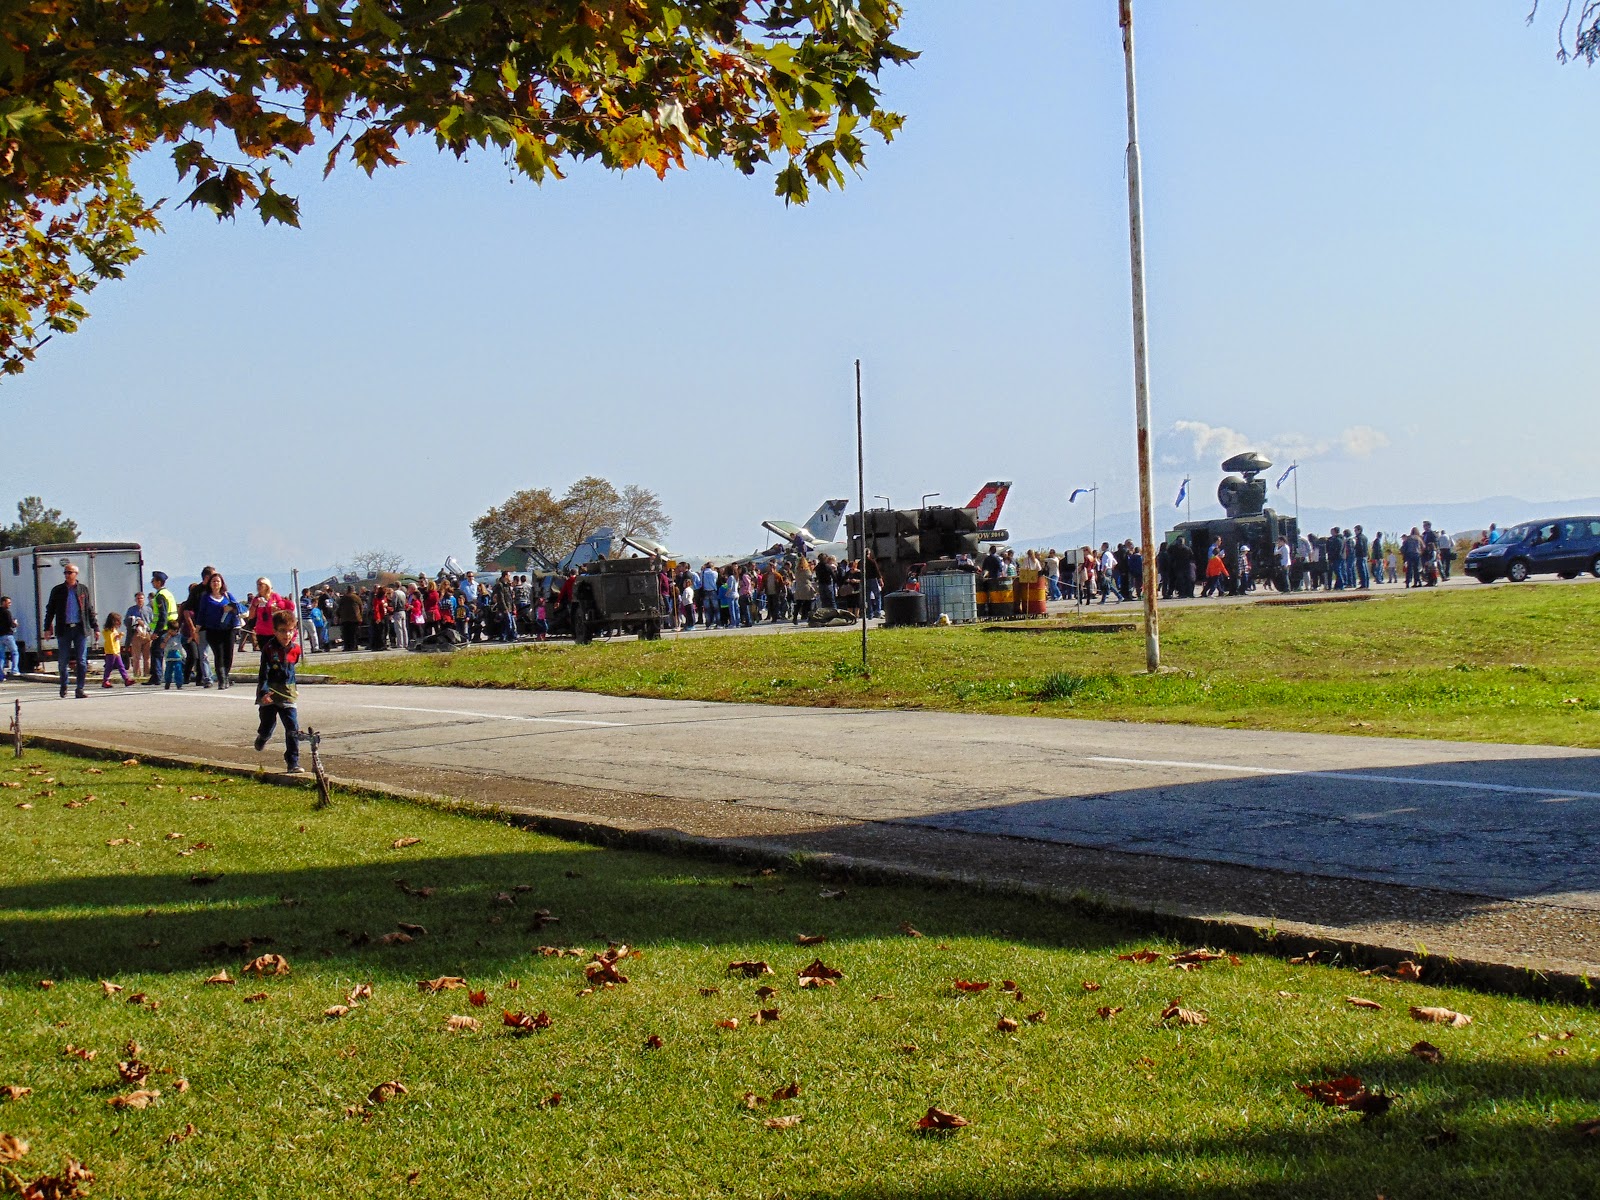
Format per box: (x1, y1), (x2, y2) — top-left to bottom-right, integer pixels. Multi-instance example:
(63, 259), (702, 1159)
(0, 0), (915, 373)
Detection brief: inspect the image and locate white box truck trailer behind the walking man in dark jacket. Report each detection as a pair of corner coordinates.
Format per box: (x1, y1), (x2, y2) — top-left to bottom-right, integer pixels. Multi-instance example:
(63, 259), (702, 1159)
(0, 542), (144, 670)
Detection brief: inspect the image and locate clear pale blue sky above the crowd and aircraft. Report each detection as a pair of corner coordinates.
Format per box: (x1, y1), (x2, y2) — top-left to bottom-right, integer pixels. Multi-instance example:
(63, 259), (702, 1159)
(0, 0), (1600, 576)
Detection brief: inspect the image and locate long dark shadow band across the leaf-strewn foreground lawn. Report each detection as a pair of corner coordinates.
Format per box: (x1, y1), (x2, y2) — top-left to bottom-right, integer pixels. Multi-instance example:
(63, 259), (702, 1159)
(0, 848), (1123, 979)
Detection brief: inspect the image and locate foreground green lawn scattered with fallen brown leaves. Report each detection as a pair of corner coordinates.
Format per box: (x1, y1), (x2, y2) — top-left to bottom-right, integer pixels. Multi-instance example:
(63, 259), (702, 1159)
(0, 752), (1600, 1200)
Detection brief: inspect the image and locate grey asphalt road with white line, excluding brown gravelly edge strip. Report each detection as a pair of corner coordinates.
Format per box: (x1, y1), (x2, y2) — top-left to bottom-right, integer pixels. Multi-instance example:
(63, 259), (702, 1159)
(15, 683), (1600, 912)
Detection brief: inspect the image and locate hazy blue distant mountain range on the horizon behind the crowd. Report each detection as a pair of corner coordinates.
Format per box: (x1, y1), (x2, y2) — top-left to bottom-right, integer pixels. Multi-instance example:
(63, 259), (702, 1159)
(1011, 496), (1600, 550)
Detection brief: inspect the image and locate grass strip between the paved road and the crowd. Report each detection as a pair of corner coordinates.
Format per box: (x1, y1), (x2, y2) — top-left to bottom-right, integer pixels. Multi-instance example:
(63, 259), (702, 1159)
(315, 584), (1600, 747)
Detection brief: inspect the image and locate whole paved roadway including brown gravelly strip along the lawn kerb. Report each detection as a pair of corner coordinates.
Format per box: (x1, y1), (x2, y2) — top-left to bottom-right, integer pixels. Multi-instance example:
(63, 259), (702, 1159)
(15, 686), (1600, 998)
